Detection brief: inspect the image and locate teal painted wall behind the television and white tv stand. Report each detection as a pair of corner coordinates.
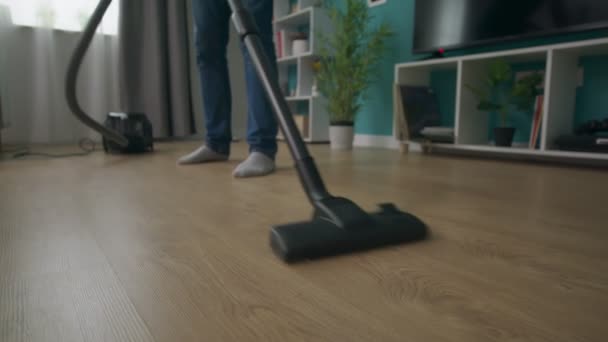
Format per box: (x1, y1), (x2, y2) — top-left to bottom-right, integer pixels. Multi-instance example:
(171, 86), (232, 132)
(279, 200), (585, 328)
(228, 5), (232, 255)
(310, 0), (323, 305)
(355, 0), (608, 140)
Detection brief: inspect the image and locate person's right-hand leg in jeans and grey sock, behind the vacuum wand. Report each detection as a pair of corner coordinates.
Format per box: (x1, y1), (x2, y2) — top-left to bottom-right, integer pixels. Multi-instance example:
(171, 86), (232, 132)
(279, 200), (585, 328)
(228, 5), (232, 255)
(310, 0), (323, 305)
(235, 0), (278, 177)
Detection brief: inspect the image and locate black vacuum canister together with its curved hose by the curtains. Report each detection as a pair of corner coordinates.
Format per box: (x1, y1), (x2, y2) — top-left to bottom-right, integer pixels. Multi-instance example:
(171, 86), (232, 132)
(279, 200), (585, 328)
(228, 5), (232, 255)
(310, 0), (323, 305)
(65, 0), (154, 153)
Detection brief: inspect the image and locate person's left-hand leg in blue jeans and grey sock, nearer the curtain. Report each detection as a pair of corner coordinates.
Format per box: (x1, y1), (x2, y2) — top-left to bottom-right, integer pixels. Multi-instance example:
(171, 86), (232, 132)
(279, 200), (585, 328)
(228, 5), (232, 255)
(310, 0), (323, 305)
(179, 0), (232, 164)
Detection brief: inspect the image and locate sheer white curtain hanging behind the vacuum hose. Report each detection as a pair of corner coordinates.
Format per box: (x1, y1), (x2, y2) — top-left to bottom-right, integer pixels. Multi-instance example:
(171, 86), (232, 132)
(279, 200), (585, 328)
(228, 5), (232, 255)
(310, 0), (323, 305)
(0, 5), (120, 144)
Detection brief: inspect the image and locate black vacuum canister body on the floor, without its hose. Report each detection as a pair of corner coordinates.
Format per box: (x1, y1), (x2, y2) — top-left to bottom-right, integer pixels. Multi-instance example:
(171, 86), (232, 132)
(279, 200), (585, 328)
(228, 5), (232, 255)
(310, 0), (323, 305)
(102, 112), (154, 154)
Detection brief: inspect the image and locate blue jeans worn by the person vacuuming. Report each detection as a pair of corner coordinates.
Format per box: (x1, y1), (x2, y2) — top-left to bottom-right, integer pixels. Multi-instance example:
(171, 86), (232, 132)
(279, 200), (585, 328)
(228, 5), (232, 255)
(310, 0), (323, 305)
(192, 0), (278, 158)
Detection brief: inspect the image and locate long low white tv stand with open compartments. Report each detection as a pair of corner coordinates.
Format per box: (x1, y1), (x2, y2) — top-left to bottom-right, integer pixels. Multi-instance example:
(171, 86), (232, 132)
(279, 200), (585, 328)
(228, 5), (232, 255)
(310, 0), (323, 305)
(394, 38), (608, 164)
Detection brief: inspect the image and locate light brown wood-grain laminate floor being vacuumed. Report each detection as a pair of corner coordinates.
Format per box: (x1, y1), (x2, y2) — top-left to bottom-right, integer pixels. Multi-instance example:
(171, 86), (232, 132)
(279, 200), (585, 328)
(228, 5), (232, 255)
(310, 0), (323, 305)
(0, 143), (608, 342)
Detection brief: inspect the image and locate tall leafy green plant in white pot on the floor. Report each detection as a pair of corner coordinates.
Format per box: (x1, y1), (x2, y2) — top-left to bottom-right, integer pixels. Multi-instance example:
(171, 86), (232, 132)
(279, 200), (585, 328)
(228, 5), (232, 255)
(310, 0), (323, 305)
(315, 0), (392, 149)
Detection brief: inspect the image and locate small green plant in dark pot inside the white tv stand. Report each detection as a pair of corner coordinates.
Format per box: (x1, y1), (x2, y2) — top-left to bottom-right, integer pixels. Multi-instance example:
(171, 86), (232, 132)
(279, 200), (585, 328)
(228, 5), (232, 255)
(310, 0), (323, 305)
(466, 60), (543, 147)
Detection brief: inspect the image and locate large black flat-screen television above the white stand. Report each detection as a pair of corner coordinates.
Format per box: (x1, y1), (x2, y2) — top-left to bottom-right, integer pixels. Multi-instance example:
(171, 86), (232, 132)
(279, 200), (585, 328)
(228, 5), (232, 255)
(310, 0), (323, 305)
(414, 0), (608, 53)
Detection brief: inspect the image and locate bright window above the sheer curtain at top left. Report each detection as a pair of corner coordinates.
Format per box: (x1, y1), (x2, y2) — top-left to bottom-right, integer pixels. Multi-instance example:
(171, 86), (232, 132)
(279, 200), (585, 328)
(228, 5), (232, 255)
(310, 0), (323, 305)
(0, 0), (119, 35)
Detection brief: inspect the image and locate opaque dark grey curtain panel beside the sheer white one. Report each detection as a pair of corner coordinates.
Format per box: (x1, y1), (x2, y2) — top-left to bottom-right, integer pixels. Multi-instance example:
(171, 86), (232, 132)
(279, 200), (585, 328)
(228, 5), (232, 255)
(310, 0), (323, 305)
(119, 0), (196, 138)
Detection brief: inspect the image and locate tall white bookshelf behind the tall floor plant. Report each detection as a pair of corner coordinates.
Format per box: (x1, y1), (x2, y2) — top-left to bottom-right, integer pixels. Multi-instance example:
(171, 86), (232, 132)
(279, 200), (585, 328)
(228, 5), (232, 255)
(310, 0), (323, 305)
(273, 0), (331, 143)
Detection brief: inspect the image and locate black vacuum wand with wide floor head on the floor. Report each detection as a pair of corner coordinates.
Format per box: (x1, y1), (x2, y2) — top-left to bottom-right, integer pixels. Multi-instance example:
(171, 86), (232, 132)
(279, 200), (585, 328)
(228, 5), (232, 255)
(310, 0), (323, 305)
(69, 0), (428, 263)
